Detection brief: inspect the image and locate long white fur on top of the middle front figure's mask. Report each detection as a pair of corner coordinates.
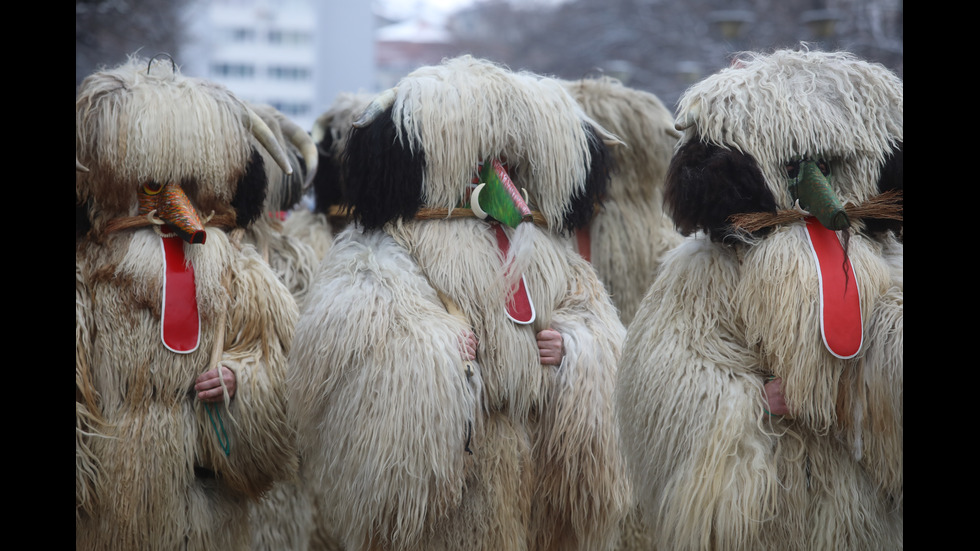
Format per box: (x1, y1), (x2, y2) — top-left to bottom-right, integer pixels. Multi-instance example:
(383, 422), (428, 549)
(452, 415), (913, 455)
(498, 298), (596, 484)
(392, 56), (612, 227)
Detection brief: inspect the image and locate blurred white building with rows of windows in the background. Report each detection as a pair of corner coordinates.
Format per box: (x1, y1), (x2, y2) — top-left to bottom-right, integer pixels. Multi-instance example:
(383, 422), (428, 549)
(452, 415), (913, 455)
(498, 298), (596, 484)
(177, 0), (377, 129)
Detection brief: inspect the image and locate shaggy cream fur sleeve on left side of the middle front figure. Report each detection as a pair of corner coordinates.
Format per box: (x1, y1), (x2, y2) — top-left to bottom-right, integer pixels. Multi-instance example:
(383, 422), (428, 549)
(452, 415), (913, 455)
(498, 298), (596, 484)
(290, 223), (480, 548)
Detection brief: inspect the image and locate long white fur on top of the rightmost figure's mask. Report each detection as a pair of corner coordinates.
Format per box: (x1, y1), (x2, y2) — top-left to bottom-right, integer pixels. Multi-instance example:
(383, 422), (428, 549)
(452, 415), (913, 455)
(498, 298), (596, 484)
(677, 49), (904, 211)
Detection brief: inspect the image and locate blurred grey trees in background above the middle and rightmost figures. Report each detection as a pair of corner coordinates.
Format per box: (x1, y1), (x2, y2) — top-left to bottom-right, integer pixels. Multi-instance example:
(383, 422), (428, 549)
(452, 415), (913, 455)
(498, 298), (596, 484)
(451, 0), (903, 109)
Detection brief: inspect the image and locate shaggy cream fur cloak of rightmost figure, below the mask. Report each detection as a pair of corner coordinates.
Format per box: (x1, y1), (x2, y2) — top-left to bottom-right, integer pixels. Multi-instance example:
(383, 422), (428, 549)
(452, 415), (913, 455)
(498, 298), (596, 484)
(617, 227), (903, 549)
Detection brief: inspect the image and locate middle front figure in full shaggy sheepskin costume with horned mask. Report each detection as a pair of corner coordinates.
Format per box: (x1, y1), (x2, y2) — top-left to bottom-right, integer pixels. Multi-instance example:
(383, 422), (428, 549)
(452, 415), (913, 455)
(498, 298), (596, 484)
(289, 57), (631, 551)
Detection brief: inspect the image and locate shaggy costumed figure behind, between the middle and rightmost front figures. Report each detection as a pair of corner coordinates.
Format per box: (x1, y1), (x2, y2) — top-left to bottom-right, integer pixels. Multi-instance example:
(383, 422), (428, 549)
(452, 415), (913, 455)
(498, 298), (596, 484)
(565, 77), (683, 325)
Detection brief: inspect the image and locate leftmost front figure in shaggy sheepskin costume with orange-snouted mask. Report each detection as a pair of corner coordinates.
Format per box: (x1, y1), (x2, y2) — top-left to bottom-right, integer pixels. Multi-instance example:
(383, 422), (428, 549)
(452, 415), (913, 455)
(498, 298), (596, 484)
(75, 58), (298, 551)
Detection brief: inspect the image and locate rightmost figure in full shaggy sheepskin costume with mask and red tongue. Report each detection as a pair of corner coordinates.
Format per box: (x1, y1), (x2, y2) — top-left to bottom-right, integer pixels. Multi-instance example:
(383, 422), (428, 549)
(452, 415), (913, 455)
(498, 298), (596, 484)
(617, 49), (903, 550)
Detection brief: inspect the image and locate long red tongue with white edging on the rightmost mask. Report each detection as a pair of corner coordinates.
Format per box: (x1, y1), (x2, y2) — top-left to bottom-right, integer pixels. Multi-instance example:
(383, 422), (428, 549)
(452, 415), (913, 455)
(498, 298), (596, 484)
(806, 217), (863, 359)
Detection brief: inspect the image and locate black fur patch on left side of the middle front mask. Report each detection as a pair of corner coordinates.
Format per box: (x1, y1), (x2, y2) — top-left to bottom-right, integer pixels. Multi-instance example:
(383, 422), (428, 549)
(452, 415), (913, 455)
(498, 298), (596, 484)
(342, 108), (425, 229)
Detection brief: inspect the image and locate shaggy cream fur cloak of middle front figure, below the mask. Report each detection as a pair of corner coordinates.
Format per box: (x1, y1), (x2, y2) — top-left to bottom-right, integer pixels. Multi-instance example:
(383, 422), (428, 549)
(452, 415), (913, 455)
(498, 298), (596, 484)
(289, 218), (630, 550)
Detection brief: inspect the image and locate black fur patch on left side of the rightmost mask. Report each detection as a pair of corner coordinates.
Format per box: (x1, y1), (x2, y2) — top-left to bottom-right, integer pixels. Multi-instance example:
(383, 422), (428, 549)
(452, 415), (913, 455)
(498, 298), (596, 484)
(664, 140), (776, 241)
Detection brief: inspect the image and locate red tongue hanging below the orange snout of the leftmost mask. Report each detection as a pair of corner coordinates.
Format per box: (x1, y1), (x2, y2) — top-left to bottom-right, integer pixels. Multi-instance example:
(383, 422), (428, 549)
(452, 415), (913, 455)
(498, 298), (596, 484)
(161, 237), (201, 354)
